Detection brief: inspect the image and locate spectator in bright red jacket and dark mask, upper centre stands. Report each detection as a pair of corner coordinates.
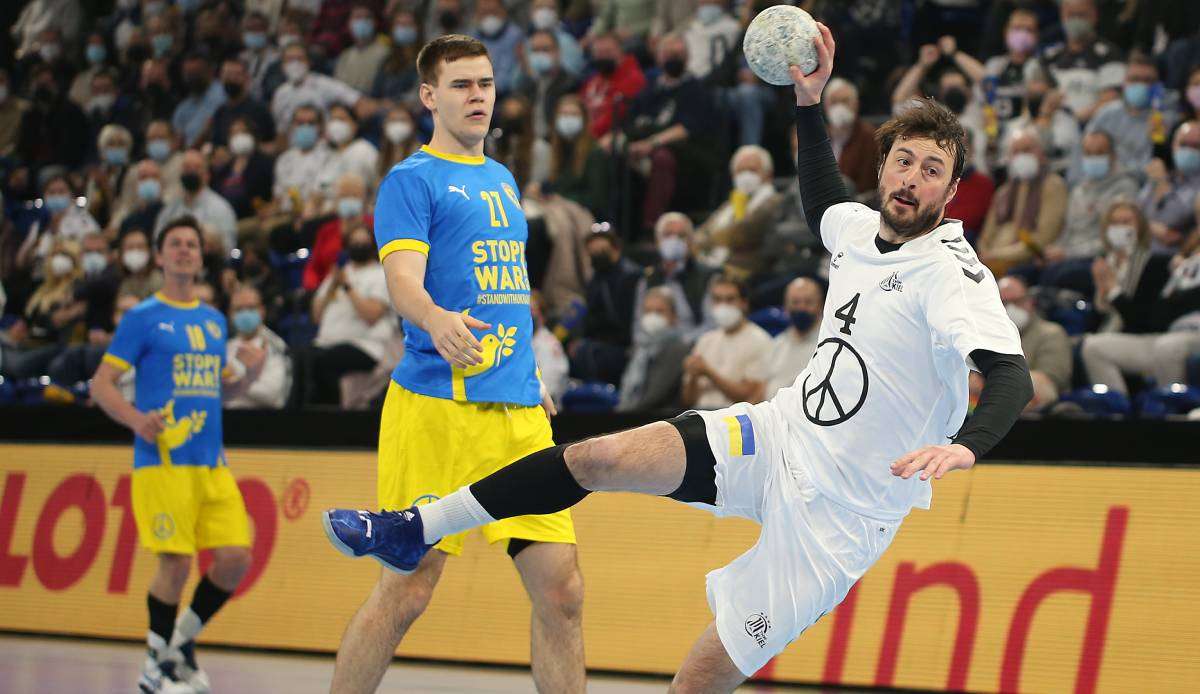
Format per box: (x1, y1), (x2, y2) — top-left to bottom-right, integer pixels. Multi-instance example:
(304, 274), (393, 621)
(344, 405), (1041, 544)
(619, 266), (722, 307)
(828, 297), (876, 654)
(580, 32), (646, 139)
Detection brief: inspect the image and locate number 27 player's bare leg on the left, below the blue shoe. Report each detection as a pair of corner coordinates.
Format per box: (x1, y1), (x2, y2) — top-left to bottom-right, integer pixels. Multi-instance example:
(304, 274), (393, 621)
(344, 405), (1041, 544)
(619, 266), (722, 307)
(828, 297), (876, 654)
(329, 551), (446, 694)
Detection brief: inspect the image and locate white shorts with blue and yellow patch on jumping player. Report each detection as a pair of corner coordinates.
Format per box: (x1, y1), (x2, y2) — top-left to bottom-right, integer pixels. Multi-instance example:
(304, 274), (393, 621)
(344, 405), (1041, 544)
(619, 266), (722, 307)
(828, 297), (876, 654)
(691, 401), (901, 677)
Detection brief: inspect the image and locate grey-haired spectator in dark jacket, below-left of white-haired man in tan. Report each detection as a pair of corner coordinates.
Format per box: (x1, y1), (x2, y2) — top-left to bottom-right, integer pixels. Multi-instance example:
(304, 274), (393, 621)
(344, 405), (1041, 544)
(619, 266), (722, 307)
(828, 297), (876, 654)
(634, 213), (718, 345)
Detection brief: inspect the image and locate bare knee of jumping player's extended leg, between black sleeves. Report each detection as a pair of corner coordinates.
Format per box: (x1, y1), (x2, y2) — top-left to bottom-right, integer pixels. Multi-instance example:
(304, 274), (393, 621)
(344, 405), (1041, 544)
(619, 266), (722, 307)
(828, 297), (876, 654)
(565, 421), (688, 496)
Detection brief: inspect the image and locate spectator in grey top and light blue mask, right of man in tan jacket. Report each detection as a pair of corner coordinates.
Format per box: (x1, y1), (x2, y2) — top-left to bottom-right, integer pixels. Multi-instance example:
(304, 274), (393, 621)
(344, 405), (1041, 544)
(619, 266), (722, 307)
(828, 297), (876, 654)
(1014, 131), (1138, 295)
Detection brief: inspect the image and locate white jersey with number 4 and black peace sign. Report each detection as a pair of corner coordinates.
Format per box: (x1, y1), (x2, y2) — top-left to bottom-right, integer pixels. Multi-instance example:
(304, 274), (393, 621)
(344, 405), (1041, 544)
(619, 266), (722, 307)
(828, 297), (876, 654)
(774, 203), (1021, 520)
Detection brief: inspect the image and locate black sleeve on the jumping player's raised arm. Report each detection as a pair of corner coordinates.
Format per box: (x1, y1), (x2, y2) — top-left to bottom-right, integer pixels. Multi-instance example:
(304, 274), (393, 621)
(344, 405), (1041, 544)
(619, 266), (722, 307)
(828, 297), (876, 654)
(796, 103), (853, 241)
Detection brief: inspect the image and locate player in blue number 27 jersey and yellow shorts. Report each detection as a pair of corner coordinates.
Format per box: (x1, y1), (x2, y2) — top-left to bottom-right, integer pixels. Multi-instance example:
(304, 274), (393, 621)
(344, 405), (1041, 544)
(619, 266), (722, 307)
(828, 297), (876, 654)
(316, 35), (584, 694)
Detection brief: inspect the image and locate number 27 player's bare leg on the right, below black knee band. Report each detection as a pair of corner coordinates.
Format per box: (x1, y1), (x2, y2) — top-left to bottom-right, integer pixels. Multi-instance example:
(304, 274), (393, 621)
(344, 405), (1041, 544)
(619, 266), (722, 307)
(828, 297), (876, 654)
(514, 543), (587, 694)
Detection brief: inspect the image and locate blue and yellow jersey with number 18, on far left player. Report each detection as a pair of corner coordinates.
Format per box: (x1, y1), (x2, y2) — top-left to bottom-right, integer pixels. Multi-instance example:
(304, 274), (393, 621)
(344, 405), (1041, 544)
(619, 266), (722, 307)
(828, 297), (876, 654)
(104, 293), (228, 469)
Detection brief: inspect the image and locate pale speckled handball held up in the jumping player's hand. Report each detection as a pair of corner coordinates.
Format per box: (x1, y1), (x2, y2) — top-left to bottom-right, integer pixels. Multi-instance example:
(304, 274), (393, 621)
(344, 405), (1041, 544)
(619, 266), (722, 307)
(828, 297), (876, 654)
(742, 5), (821, 86)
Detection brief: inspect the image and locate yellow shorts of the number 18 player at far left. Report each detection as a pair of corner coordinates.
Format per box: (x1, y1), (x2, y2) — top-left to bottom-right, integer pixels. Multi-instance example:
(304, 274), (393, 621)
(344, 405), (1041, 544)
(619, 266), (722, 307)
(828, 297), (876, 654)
(133, 465), (250, 555)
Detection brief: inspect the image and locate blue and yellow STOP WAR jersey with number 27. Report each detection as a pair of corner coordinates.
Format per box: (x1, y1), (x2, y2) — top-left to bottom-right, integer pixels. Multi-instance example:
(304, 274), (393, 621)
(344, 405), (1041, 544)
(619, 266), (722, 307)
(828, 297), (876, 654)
(376, 146), (541, 405)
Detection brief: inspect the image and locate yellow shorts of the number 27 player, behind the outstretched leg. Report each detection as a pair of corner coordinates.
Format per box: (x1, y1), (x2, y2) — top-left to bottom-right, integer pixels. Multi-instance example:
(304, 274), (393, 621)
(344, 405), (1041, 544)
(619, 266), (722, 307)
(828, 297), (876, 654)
(378, 382), (575, 556)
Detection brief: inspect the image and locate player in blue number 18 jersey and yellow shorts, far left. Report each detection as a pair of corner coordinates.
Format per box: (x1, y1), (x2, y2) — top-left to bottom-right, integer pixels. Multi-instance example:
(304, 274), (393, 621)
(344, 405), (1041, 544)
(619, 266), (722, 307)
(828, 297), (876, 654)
(91, 217), (258, 693)
